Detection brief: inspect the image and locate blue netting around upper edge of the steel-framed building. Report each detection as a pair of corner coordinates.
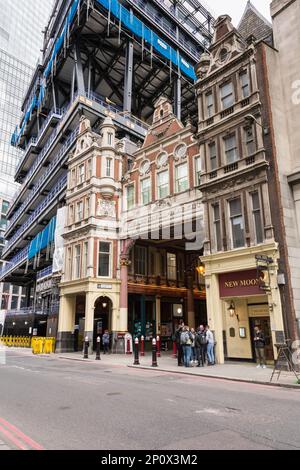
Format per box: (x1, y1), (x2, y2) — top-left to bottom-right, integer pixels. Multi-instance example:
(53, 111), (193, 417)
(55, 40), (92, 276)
(11, 0), (196, 145)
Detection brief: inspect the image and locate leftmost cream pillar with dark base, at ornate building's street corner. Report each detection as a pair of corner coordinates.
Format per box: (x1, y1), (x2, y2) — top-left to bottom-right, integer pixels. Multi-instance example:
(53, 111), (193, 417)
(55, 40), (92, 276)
(56, 295), (76, 353)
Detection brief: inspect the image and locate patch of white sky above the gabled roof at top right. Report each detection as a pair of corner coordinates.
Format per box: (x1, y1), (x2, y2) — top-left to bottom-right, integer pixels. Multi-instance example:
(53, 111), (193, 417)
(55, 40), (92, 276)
(203, 0), (271, 26)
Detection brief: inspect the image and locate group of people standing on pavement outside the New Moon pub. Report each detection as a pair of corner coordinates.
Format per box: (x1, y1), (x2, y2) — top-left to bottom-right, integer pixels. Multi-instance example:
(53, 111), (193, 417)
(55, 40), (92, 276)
(175, 321), (215, 367)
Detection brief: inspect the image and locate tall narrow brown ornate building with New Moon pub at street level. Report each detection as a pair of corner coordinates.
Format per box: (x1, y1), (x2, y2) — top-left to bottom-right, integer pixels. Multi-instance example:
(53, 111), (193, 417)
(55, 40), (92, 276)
(196, 1), (299, 361)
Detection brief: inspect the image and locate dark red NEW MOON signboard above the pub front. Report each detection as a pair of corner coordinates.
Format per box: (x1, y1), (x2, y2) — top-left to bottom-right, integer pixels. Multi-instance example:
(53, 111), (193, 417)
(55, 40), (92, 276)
(219, 269), (262, 298)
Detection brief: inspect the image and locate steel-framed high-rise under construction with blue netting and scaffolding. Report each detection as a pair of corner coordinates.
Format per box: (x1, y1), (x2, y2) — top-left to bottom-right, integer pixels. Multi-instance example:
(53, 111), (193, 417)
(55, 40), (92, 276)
(0, 0), (214, 334)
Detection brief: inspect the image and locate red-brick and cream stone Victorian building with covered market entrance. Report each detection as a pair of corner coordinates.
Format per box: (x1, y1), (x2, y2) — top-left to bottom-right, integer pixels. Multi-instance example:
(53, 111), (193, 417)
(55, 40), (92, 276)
(57, 98), (206, 351)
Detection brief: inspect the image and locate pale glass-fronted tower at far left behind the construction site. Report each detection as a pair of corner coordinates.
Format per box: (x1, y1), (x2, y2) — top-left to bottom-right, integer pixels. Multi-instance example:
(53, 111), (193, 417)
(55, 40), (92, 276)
(0, 0), (54, 326)
